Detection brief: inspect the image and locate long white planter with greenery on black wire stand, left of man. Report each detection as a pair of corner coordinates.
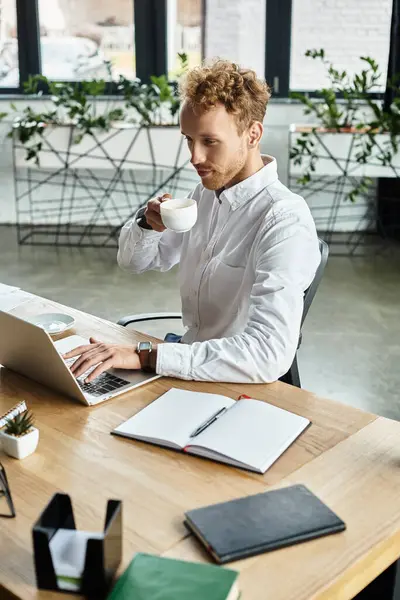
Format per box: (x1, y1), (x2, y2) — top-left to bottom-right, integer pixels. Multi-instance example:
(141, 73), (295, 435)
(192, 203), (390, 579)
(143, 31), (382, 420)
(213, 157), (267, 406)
(9, 54), (190, 246)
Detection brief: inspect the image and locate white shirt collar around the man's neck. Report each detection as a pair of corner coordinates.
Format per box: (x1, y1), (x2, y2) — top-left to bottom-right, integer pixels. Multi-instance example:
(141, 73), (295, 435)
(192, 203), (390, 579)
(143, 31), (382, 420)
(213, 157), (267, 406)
(215, 154), (278, 210)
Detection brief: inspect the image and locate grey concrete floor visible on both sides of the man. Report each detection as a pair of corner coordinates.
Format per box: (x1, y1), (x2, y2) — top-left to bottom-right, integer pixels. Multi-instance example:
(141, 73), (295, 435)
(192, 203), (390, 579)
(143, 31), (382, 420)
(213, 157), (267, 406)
(0, 226), (400, 419)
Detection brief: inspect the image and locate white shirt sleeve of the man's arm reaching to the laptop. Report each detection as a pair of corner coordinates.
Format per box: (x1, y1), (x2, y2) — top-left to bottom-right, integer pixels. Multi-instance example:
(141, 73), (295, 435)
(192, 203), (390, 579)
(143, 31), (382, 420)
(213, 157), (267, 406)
(157, 215), (321, 383)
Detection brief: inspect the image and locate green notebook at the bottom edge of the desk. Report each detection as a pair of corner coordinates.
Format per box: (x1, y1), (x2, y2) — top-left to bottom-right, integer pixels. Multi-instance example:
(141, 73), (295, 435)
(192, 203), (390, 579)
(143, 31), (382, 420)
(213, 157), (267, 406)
(107, 553), (239, 600)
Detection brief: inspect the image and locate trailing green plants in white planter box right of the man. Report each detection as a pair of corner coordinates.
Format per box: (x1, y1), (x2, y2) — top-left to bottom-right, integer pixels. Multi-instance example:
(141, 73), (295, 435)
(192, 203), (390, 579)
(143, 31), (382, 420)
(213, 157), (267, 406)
(289, 49), (400, 202)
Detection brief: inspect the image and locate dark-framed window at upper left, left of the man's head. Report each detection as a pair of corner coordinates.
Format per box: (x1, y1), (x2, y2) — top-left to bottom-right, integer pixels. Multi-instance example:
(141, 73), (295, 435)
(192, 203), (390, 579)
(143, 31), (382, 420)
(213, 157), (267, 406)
(0, 0), (204, 93)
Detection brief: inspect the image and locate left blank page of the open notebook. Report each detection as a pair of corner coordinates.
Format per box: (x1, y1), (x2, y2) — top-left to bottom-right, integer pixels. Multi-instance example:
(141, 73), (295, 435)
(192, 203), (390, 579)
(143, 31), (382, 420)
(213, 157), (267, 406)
(114, 388), (235, 448)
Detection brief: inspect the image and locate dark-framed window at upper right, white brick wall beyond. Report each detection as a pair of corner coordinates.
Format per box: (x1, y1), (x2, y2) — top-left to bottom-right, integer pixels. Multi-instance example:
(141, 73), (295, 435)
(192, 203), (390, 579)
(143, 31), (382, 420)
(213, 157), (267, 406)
(265, 0), (392, 98)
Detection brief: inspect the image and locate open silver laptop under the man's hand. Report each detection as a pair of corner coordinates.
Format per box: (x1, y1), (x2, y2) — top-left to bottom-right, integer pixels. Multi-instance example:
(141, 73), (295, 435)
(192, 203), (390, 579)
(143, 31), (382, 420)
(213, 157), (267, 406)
(0, 311), (160, 406)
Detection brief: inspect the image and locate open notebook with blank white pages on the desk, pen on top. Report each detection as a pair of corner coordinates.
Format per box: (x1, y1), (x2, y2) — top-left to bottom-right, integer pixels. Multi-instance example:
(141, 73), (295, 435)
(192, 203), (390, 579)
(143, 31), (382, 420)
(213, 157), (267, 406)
(112, 388), (310, 473)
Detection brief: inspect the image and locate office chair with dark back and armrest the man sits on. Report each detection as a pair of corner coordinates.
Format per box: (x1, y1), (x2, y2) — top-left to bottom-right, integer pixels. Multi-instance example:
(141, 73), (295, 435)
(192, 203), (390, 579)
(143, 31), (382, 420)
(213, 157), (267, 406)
(118, 239), (329, 387)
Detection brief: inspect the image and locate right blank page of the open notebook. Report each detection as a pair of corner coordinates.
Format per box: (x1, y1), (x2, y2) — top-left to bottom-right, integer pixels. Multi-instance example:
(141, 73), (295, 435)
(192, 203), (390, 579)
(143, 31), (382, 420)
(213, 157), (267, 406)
(191, 400), (309, 472)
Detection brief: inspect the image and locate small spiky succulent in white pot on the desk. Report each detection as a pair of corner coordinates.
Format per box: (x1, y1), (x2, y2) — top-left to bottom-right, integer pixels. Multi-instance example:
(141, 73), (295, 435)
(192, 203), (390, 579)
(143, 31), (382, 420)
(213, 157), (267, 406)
(0, 411), (39, 459)
